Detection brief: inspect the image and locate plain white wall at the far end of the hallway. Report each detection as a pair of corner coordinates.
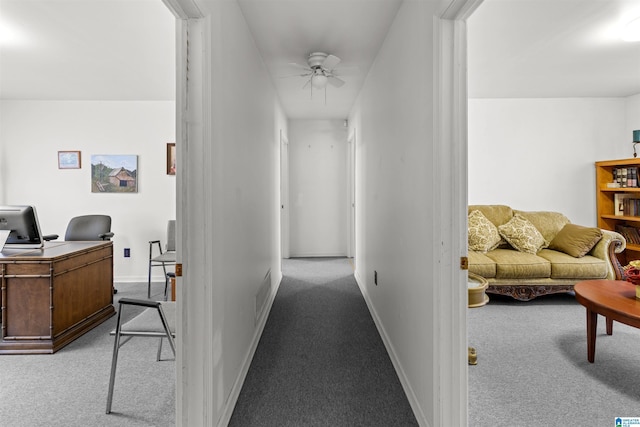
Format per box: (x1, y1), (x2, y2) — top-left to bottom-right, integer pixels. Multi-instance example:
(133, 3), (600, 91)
(289, 120), (348, 257)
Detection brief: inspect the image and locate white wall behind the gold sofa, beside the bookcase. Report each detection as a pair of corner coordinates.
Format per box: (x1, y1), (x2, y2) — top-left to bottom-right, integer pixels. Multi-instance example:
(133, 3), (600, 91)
(468, 98), (637, 226)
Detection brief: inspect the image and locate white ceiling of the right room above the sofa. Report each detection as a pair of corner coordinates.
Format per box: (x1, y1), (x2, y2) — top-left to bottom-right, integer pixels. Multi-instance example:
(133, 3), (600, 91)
(468, 0), (640, 98)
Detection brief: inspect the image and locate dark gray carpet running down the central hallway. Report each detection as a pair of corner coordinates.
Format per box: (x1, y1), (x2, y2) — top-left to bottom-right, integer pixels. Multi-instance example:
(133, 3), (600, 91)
(229, 258), (417, 427)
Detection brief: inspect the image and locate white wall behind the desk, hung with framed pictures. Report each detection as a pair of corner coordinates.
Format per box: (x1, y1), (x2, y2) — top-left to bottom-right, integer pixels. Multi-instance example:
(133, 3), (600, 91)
(0, 100), (176, 289)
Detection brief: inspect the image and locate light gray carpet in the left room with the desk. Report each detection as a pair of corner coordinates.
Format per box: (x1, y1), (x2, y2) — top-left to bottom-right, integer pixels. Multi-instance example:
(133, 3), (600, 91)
(0, 282), (175, 427)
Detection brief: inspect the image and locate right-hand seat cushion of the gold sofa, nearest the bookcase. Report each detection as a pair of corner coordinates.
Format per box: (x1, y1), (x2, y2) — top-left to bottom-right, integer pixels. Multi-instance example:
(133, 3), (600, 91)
(538, 249), (608, 280)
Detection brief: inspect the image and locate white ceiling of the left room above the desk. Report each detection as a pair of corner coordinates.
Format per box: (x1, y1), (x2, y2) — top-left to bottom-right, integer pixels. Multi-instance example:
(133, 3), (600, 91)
(0, 0), (175, 100)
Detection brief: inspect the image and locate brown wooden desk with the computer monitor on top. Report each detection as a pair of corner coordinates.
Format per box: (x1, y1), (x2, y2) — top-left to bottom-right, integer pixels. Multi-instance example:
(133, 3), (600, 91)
(0, 241), (115, 354)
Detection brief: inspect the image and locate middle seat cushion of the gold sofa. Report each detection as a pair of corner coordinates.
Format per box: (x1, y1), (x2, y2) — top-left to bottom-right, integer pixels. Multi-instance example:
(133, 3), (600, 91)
(487, 249), (552, 279)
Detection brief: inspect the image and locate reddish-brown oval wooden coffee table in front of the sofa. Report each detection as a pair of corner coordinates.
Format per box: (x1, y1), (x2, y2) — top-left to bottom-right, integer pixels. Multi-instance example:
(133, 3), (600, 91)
(574, 280), (640, 363)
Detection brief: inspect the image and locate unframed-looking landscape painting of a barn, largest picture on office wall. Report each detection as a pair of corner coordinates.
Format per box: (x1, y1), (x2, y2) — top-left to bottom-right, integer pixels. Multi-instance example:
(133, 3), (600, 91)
(91, 154), (138, 193)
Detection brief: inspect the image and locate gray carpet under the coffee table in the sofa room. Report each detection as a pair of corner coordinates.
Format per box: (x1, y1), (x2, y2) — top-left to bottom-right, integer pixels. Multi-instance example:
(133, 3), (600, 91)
(468, 294), (640, 427)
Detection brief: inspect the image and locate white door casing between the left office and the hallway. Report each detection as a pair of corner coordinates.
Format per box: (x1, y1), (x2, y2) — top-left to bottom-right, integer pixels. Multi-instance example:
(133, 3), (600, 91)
(176, 13), (211, 426)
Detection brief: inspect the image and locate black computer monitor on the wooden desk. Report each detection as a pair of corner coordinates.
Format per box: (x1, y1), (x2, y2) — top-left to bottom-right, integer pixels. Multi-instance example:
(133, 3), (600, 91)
(0, 206), (44, 249)
